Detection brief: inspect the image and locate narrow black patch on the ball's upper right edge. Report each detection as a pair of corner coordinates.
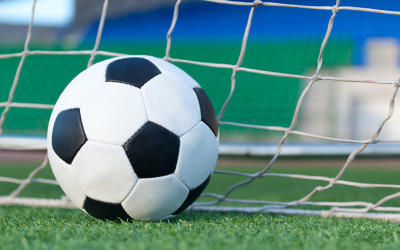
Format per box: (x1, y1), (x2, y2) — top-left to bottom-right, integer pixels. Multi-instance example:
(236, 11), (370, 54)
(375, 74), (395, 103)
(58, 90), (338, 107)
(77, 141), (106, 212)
(193, 88), (218, 136)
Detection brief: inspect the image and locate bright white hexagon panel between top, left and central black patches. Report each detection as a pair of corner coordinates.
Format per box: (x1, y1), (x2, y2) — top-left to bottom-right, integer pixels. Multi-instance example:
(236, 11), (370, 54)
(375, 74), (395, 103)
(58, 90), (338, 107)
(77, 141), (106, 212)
(81, 82), (148, 145)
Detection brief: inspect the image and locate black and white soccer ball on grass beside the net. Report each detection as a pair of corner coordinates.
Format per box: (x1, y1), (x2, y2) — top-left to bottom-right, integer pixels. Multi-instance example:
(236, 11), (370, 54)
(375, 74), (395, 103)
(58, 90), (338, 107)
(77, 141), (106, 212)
(47, 56), (219, 221)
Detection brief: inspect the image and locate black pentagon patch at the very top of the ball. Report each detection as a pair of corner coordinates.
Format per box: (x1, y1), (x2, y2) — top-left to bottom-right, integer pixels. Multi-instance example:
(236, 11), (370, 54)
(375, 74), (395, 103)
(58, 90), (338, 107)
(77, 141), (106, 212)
(106, 57), (161, 88)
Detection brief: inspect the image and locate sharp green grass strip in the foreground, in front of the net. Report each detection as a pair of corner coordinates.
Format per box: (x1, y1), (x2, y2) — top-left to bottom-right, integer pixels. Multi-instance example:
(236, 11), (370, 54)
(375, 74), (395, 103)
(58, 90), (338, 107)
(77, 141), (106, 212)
(0, 207), (400, 249)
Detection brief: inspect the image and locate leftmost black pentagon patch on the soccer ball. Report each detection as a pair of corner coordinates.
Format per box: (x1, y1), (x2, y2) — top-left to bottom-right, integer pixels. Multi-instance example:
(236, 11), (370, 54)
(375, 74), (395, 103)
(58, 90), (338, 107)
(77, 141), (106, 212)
(51, 108), (87, 164)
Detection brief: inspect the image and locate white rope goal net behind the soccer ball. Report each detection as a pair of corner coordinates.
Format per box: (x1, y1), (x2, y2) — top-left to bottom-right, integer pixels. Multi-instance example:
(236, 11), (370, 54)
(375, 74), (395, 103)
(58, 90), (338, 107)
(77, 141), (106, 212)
(0, 0), (400, 221)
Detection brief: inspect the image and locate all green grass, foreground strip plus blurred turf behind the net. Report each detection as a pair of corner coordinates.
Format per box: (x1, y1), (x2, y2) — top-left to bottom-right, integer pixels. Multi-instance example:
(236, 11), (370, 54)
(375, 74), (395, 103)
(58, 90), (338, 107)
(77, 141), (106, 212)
(0, 161), (400, 249)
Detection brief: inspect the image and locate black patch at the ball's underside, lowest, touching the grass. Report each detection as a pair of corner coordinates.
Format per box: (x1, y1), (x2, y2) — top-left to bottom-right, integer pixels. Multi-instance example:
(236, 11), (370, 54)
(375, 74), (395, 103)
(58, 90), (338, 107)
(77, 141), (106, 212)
(83, 197), (132, 221)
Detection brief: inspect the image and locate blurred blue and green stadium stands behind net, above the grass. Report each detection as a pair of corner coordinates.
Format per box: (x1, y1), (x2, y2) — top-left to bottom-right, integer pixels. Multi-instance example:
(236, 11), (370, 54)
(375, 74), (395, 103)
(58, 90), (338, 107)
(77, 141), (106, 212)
(0, 0), (400, 155)
